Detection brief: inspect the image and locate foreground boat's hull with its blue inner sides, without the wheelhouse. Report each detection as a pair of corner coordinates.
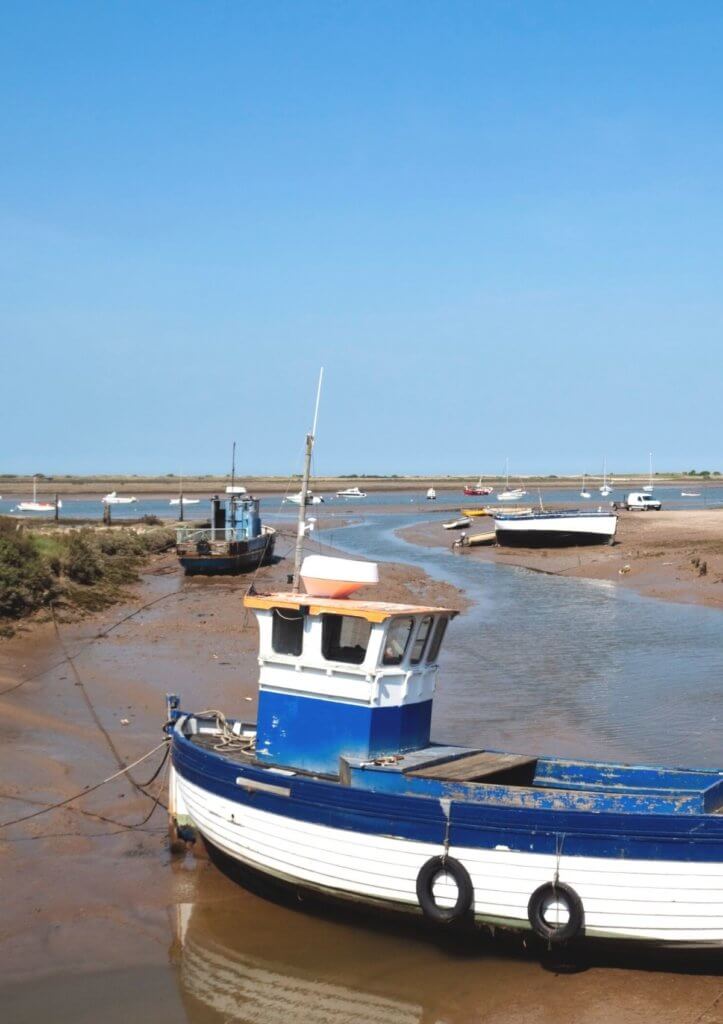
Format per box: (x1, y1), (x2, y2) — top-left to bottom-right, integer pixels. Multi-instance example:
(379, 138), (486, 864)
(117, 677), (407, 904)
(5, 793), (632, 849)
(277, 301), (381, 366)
(169, 719), (723, 948)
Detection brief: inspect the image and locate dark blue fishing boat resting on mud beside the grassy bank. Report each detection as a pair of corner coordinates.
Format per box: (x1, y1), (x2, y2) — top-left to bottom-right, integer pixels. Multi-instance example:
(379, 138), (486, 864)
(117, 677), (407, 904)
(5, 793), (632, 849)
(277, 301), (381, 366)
(176, 488), (277, 575)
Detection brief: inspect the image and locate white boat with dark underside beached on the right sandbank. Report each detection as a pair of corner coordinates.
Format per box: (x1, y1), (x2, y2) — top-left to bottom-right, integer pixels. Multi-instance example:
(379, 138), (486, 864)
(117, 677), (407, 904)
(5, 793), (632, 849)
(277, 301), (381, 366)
(495, 509), (618, 548)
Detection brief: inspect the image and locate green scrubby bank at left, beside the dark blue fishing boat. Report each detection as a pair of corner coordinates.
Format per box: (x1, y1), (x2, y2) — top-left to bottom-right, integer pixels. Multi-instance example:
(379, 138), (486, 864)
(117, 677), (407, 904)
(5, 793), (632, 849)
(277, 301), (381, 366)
(0, 518), (174, 636)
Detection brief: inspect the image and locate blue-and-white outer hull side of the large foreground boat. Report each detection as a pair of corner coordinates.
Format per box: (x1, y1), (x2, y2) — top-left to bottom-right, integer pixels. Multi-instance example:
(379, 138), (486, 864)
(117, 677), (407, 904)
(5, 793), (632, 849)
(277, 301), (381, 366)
(170, 732), (723, 946)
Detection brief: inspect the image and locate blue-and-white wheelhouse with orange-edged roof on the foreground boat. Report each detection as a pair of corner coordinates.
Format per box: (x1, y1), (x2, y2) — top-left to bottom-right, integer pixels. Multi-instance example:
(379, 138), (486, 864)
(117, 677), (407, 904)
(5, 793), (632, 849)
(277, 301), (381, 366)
(245, 594), (456, 775)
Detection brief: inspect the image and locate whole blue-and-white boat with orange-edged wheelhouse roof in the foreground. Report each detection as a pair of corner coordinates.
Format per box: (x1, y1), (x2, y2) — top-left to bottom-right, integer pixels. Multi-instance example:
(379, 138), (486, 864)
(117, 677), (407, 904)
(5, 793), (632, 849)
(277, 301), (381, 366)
(167, 558), (723, 946)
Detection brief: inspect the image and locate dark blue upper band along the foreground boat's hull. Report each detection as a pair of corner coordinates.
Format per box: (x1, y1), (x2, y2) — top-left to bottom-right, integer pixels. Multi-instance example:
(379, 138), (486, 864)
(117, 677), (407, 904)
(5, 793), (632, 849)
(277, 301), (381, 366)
(172, 733), (723, 863)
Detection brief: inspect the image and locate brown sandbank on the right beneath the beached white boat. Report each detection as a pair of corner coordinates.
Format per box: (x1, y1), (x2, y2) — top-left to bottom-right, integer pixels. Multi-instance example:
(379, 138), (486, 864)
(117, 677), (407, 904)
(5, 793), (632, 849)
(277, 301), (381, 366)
(399, 509), (723, 608)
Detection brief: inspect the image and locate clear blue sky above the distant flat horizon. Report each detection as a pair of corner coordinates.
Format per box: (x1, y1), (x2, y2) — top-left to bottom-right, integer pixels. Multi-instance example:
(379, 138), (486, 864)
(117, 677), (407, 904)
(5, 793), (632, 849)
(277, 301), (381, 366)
(0, 0), (723, 474)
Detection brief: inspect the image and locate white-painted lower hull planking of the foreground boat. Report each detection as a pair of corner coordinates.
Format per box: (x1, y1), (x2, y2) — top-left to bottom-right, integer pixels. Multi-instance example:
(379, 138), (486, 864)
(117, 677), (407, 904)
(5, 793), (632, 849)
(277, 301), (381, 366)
(170, 769), (723, 945)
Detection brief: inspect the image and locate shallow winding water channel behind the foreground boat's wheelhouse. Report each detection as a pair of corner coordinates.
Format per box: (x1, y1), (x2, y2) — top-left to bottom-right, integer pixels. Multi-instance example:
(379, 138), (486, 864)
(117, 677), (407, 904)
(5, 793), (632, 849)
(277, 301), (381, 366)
(322, 516), (723, 768)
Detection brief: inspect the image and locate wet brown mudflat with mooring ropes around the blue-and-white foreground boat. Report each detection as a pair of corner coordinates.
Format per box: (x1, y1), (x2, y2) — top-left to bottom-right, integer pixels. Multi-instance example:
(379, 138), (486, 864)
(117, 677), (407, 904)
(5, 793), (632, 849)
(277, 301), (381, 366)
(0, 538), (723, 1024)
